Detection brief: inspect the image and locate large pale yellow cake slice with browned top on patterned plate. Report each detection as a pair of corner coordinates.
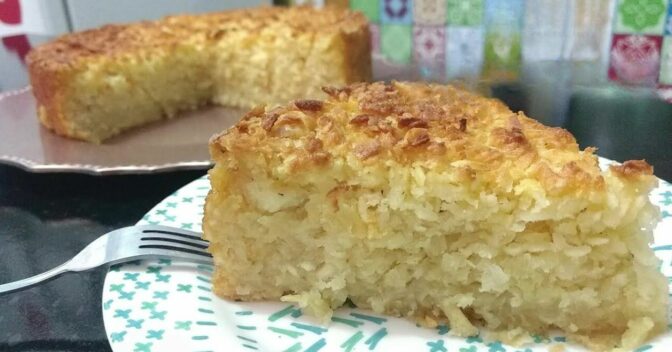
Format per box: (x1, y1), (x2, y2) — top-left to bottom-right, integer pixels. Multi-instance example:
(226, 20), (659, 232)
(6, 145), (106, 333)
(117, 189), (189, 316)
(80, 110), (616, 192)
(203, 82), (668, 350)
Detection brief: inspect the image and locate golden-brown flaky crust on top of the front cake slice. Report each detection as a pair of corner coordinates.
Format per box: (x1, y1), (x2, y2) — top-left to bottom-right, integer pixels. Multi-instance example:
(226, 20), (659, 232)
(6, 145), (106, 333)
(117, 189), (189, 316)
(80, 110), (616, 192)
(211, 82), (652, 194)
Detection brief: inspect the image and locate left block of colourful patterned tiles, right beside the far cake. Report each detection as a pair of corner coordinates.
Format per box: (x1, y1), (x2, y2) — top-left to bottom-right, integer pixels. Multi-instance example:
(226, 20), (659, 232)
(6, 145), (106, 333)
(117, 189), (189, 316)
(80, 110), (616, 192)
(350, 0), (524, 80)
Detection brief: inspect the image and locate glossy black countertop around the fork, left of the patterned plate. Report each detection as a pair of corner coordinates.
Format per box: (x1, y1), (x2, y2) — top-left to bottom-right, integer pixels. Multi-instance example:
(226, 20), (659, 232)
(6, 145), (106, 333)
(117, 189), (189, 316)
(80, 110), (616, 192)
(0, 165), (205, 351)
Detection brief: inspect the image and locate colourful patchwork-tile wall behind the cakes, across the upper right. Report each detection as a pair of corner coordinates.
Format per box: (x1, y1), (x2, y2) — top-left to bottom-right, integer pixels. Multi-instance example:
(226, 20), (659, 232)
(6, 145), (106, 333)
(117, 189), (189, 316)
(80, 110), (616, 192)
(342, 0), (672, 99)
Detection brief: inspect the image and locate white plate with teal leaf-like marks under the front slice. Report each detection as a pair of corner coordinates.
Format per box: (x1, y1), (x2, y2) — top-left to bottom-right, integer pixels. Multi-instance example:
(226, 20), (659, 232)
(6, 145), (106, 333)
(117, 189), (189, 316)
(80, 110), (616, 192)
(103, 160), (672, 352)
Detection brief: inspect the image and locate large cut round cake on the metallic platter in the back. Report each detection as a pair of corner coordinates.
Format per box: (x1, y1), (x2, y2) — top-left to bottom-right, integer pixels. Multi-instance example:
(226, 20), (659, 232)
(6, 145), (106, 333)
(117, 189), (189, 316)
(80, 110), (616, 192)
(27, 7), (371, 143)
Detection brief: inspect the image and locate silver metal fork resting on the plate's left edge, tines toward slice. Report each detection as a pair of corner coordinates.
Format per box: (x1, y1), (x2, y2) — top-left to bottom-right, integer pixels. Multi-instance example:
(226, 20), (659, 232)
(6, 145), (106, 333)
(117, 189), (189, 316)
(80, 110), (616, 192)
(0, 225), (212, 295)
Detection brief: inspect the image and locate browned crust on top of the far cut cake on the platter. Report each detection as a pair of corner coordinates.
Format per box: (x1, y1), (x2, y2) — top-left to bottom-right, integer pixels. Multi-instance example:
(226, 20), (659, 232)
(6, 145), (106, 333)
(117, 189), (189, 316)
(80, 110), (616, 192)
(28, 6), (366, 69)
